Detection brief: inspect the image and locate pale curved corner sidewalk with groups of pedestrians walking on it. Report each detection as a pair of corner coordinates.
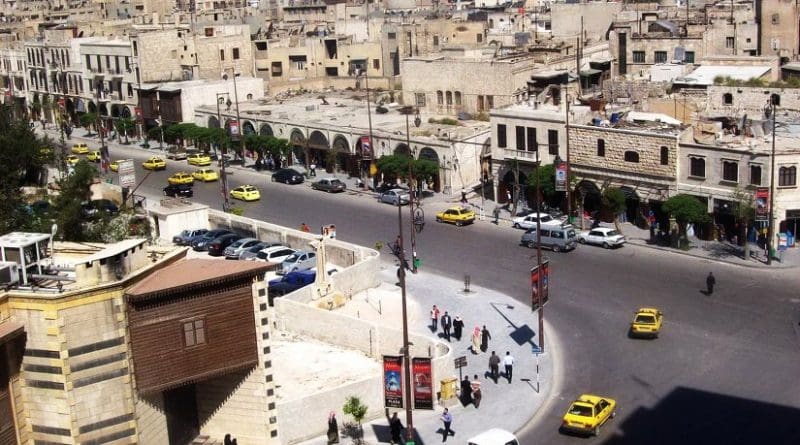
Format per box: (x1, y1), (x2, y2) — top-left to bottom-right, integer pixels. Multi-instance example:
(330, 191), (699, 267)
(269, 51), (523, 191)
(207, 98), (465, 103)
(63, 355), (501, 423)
(302, 267), (558, 445)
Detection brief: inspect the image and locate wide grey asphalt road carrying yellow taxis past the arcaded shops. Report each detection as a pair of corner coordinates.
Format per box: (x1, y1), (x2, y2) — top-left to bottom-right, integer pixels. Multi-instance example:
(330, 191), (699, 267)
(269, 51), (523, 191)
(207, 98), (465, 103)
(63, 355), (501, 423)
(67, 136), (800, 445)
